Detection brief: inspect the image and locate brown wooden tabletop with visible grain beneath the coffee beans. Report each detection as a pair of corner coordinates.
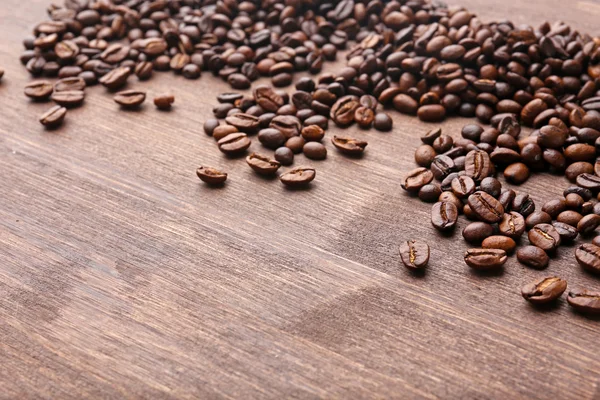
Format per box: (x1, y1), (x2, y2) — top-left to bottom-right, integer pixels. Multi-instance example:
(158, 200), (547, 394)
(0, 0), (600, 399)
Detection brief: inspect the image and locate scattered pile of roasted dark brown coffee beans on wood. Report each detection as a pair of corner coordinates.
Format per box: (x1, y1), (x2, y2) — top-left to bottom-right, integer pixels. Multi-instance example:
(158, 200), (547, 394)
(21, 0), (600, 312)
